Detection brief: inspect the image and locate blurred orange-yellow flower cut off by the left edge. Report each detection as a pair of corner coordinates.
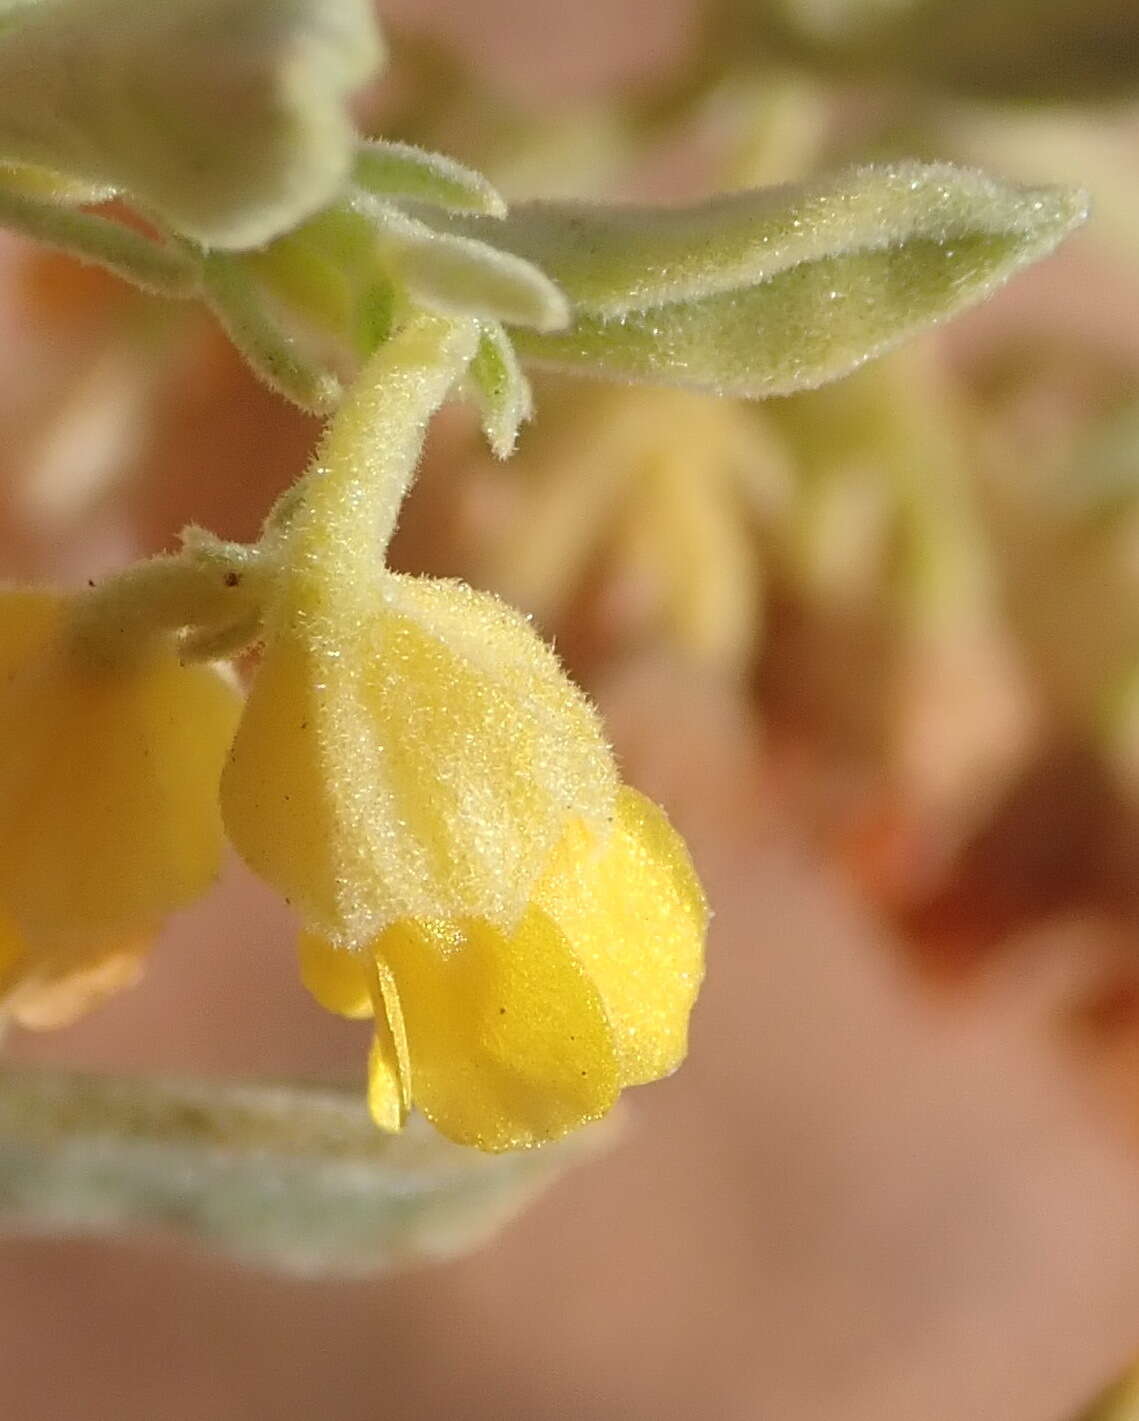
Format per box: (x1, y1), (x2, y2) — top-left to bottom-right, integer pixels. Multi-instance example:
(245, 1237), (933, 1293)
(0, 590), (240, 1026)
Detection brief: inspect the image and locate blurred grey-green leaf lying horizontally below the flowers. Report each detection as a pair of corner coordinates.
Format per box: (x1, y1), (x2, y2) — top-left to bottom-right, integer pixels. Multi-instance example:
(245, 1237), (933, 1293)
(0, 1067), (593, 1275)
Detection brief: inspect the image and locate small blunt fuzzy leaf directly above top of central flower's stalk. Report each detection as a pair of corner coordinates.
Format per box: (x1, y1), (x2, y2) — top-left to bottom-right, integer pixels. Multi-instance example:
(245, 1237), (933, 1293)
(354, 193), (570, 331)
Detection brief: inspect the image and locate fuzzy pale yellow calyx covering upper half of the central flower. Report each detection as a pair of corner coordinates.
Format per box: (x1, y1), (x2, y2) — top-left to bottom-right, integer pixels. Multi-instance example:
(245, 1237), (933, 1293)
(223, 573), (616, 946)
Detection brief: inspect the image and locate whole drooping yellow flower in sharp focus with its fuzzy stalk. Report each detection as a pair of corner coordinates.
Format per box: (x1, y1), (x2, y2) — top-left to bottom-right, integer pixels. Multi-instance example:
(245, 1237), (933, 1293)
(222, 314), (706, 1150)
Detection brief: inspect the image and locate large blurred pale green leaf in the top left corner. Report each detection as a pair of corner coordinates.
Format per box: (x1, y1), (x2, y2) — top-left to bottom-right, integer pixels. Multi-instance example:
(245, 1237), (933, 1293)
(0, 0), (382, 247)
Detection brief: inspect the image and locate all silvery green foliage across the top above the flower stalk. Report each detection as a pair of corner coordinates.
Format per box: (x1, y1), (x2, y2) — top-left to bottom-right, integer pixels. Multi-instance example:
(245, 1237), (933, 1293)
(0, 0), (1085, 431)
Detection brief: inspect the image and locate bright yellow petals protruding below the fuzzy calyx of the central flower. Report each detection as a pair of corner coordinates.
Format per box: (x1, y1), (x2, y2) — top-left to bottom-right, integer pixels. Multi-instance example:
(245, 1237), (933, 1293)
(301, 787), (707, 1150)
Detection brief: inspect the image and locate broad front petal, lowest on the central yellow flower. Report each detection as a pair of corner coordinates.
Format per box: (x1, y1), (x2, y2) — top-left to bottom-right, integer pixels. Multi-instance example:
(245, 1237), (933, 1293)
(375, 909), (619, 1150)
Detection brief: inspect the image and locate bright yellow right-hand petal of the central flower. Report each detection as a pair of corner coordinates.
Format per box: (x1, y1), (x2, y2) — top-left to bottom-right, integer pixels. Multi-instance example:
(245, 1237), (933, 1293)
(534, 786), (709, 1086)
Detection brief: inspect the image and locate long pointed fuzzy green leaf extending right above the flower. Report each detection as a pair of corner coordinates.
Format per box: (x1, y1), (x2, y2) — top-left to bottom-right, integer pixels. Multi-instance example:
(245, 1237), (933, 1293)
(452, 163), (1086, 396)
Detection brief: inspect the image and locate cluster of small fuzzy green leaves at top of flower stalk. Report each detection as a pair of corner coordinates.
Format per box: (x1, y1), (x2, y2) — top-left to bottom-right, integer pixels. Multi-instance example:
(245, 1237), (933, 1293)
(202, 154), (559, 420)
